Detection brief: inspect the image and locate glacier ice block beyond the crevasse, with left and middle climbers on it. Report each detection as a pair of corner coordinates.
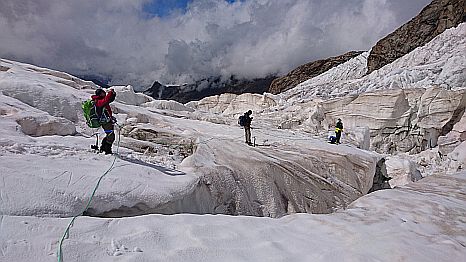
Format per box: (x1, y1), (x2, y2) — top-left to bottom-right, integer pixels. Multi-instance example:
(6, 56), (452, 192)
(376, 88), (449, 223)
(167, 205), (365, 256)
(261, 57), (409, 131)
(0, 56), (381, 217)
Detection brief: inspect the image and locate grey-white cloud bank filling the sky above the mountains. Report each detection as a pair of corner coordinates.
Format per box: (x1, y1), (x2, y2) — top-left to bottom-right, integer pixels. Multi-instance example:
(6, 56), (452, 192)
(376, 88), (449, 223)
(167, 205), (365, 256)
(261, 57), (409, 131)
(0, 0), (430, 88)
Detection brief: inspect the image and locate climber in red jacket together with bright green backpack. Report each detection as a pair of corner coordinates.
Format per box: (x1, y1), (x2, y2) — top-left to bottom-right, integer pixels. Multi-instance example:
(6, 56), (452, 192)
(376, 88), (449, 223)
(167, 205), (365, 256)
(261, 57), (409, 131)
(82, 88), (116, 154)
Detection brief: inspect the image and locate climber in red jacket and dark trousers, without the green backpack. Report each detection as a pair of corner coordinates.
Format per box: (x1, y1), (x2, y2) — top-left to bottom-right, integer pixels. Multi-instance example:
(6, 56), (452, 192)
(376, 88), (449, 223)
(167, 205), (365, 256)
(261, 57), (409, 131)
(91, 88), (116, 154)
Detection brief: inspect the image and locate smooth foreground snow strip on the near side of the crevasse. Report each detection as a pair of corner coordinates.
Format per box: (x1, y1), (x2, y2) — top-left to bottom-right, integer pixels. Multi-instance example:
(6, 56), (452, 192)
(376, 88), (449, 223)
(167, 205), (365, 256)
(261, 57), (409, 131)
(0, 173), (466, 262)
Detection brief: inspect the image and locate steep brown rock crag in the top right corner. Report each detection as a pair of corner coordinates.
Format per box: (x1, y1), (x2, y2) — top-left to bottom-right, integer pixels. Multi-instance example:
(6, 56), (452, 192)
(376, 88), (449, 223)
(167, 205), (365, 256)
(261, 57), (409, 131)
(367, 0), (466, 74)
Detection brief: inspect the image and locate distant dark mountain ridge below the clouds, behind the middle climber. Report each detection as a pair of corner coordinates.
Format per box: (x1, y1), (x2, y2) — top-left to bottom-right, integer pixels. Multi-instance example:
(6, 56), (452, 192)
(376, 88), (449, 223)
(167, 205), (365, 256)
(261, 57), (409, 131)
(144, 76), (275, 103)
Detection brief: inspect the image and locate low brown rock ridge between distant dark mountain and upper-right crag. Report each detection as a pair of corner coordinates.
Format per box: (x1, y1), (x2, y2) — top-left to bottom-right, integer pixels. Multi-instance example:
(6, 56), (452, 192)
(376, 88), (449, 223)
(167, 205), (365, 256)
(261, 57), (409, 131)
(269, 51), (362, 94)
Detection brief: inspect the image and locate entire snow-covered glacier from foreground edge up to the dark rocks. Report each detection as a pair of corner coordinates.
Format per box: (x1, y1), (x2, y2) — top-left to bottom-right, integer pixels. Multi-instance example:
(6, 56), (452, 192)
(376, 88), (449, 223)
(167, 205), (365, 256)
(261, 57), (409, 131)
(0, 24), (466, 262)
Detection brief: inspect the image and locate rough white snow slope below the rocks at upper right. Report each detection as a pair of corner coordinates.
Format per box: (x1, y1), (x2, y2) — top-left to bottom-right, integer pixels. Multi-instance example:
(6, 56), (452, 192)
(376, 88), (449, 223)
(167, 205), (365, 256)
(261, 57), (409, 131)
(282, 23), (466, 102)
